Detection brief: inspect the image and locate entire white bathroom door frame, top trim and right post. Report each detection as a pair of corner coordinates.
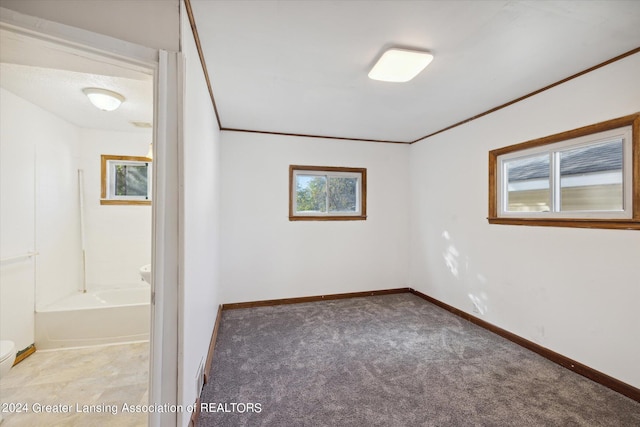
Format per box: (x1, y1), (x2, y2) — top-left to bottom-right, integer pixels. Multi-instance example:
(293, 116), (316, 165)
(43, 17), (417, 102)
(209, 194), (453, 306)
(0, 7), (183, 426)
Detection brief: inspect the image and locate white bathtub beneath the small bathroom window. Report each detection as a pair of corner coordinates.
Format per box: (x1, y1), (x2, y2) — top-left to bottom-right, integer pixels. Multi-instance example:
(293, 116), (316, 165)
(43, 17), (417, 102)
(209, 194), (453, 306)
(35, 285), (151, 350)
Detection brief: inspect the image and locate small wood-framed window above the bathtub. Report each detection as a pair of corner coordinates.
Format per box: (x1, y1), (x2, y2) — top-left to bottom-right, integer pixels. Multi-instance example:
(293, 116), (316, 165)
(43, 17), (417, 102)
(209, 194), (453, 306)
(100, 154), (151, 205)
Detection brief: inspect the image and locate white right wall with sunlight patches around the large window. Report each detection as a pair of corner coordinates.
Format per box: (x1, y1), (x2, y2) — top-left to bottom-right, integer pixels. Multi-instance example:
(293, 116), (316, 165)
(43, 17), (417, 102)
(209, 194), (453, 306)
(410, 54), (640, 387)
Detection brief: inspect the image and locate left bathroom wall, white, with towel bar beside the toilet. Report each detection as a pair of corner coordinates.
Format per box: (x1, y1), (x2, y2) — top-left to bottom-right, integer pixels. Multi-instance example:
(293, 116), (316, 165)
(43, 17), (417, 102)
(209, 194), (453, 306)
(0, 89), (80, 349)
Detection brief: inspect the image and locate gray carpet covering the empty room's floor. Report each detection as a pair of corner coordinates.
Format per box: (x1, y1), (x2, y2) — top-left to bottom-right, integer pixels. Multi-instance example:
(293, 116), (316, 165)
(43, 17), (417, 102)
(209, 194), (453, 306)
(198, 293), (640, 427)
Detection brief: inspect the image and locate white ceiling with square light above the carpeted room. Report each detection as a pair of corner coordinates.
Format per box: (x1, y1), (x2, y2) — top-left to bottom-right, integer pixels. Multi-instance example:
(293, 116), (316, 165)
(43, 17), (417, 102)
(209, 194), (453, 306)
(190, 0), (640, 142)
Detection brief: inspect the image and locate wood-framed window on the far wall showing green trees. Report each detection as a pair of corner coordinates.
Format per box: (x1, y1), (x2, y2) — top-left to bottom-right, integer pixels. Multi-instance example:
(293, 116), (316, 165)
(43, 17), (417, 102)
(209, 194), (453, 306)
(289, 165), (367, 221)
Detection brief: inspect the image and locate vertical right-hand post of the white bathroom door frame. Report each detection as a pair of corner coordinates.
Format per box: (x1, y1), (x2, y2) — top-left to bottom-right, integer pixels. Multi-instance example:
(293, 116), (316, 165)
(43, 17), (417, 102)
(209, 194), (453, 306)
(149, 50), (183, 427)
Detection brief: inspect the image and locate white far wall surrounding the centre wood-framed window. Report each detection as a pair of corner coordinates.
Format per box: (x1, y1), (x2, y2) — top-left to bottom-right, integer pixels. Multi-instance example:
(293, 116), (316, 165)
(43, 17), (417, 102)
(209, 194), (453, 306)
(221, 132), (409, 303)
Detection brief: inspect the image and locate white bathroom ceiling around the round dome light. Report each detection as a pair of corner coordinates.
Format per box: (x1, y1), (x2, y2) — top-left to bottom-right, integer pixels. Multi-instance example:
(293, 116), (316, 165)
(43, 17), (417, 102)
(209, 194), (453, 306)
(0, 30), (153, 132)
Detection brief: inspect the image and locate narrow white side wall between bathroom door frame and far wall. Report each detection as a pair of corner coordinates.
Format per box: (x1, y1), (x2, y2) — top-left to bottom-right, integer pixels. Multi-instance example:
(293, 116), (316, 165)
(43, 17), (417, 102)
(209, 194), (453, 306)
(178, 5), (220, 426)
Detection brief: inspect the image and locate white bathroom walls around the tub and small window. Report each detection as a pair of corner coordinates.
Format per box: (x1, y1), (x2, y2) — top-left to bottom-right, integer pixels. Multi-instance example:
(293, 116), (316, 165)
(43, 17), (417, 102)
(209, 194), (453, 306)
(0, 89), (151, 350)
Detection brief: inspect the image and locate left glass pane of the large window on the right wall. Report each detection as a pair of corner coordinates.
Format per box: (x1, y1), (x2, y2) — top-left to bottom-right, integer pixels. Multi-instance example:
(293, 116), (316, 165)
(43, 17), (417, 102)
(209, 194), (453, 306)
(504, 153), (551, 212)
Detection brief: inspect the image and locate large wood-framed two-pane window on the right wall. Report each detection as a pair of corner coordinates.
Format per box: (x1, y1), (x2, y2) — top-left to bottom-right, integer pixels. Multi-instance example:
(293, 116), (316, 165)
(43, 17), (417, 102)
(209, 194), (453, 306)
(489, 114), (640, 229)
